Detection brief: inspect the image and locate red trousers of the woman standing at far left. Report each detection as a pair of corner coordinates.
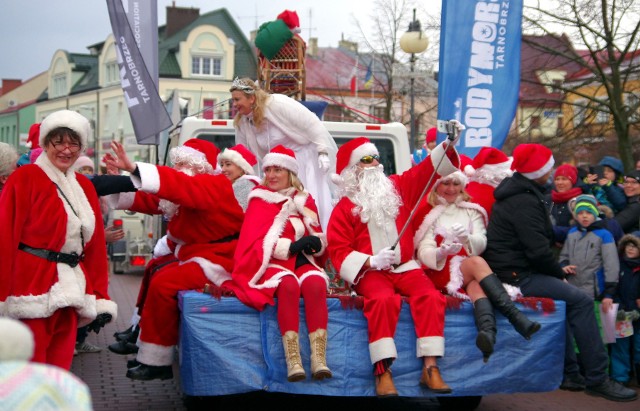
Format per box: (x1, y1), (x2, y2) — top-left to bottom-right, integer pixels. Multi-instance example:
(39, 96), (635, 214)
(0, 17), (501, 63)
(21, 307), (78, 370)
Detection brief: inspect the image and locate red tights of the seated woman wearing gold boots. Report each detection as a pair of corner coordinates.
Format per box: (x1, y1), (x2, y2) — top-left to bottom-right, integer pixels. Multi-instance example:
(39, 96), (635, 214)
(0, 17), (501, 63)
(276, 275), (329, 335)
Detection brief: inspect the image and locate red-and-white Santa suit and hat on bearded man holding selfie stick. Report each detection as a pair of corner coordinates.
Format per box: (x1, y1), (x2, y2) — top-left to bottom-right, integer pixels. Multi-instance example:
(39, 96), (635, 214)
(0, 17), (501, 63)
(327, 137), (459, 395)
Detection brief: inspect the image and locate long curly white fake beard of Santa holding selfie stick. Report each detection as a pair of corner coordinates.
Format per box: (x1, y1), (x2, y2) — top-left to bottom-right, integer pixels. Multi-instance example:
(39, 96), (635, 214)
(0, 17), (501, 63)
(343, 165), (402, 227)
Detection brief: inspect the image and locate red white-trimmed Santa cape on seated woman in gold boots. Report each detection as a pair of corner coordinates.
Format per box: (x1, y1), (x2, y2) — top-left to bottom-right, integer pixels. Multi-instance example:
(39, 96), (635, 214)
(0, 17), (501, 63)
(225, 186), (326, 310)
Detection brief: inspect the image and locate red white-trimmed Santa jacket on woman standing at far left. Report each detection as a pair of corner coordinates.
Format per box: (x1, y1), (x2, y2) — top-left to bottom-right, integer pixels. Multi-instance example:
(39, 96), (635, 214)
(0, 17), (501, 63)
(0, 155), (117, 325)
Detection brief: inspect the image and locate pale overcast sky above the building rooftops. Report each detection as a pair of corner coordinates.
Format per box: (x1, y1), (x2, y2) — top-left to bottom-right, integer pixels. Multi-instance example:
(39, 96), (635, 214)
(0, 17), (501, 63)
(0, 0), (382, 80)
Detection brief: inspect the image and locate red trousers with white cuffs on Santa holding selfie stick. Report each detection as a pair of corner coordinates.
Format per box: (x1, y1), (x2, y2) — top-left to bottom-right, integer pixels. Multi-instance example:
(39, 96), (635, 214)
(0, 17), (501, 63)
(354, 269), (446, 343)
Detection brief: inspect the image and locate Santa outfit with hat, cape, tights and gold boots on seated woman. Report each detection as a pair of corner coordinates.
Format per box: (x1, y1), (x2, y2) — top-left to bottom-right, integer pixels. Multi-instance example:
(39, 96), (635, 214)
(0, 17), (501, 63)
(228, 146), (331, 381)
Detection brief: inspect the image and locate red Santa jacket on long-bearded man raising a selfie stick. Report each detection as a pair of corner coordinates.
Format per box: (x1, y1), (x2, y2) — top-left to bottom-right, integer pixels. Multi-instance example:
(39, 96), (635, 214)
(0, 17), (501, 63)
(327, 143), (459, 284)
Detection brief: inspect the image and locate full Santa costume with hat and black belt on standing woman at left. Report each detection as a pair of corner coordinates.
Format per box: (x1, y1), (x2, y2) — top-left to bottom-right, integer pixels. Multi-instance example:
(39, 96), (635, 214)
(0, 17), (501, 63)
(0, 110), (117, 369)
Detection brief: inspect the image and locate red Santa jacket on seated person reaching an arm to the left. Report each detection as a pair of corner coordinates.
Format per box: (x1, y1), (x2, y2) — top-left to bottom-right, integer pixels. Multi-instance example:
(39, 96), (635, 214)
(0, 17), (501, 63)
(111, 163), (244, 285)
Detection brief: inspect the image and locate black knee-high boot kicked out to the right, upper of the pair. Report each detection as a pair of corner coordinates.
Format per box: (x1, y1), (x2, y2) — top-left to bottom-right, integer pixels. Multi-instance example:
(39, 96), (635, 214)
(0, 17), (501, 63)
(480, 273), (540, 340)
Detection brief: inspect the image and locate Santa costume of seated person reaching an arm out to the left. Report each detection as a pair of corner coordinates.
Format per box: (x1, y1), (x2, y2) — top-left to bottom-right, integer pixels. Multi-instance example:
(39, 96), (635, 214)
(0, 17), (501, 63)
(112, 139), (244, 379)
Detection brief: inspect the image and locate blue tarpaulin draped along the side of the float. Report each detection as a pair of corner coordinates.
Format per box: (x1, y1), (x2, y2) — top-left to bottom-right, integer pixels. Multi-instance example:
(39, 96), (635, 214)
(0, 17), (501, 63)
(180, 291), (565, 397)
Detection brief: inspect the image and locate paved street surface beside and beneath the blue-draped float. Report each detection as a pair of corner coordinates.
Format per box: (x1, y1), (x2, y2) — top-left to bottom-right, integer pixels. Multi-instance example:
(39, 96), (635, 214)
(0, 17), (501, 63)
(71, 273), (640, 411)
